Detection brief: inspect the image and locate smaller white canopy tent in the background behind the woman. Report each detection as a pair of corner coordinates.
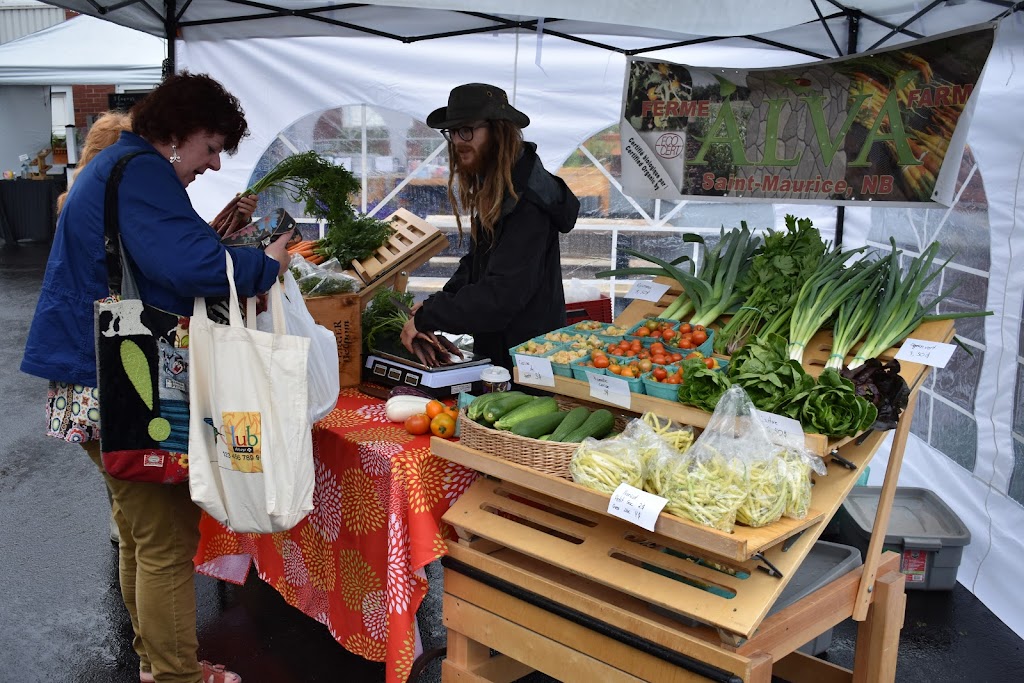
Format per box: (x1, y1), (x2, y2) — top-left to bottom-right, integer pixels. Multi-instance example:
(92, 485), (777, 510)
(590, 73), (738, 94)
(0, 16), (165, 170)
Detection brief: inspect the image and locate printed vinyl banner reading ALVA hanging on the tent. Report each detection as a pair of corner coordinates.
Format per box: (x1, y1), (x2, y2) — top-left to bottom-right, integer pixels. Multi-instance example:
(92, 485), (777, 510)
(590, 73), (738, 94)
(621, 26), (994, 206)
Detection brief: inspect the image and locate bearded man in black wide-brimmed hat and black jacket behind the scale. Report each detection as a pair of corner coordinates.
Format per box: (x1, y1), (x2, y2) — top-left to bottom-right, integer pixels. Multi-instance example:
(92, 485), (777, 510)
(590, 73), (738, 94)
(401, 83), (580, 376)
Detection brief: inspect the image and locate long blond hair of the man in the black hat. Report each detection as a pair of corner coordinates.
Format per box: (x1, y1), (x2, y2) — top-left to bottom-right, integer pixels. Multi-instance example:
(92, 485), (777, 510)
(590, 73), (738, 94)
(449, 120), (522, 245)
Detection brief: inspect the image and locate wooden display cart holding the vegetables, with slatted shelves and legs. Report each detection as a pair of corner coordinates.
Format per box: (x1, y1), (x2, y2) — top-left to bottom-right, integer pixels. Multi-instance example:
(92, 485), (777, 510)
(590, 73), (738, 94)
(431, 295), (953, 683)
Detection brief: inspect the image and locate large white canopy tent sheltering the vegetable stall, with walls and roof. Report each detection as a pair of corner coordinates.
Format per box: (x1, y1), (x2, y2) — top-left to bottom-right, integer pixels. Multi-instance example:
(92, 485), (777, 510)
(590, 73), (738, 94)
(36, 0), (1024, 634)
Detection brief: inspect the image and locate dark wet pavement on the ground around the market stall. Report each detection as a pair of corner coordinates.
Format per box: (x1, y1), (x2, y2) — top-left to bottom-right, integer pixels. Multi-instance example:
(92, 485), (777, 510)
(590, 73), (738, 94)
(0, 237), (1024, 683)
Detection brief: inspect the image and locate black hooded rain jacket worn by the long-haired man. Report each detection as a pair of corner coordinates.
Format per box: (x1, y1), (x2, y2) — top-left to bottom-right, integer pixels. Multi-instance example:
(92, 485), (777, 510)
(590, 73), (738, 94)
(416, 142), (580, 370)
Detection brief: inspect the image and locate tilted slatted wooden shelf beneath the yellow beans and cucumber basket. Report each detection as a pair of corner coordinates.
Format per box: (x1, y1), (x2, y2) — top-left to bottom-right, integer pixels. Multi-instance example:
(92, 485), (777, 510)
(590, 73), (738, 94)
(440, 409), (897, 638)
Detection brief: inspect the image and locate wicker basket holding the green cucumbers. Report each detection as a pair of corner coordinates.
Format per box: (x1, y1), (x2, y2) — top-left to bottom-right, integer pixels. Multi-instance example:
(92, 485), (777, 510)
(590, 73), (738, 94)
(459, 396), (634, 480)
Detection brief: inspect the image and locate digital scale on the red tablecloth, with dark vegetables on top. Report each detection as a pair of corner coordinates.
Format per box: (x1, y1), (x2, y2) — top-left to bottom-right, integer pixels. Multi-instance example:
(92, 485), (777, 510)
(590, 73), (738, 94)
(362, 350), (492, 396)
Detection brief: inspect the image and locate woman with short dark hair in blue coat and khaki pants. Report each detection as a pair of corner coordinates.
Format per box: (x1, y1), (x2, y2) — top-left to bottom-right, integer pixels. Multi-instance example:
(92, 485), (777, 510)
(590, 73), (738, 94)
(22, 73), (289, 683)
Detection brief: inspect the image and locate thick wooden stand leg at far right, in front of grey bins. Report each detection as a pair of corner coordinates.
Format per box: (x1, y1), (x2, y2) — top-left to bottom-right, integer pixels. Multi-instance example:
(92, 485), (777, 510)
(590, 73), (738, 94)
(853, 571), (906, 683)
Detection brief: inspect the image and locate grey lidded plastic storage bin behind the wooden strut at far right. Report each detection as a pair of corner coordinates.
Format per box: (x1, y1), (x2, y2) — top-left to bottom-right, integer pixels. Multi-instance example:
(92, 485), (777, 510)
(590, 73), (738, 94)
(839, 486), (971, 591)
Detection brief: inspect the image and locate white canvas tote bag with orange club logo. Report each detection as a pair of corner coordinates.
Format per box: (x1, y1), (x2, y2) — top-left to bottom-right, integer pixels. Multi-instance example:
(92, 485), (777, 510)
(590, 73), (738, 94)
(188, 253), (313, 533)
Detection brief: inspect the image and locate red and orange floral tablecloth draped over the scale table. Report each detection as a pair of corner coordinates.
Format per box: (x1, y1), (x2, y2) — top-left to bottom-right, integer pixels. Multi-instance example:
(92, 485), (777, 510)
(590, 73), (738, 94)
(196, 389), (476, 683)
